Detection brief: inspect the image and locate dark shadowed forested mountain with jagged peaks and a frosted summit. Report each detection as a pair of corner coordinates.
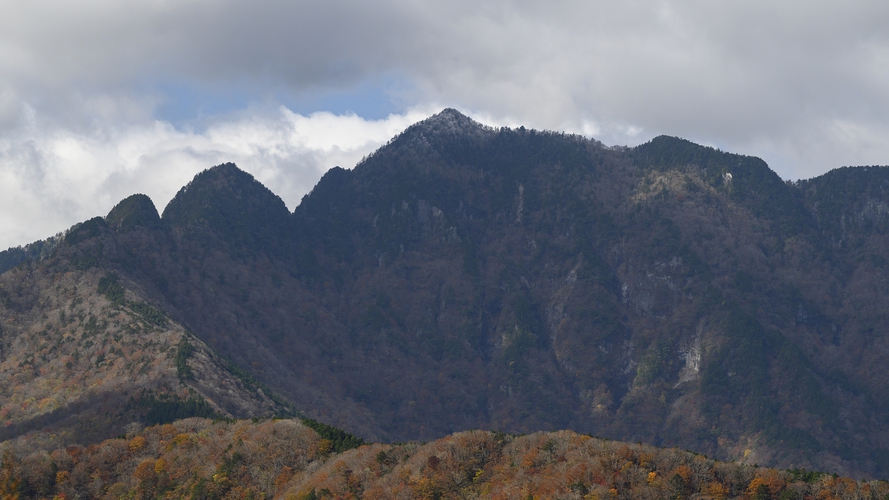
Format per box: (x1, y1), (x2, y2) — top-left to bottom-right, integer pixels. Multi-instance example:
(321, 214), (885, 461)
(0, 109), (889, 476)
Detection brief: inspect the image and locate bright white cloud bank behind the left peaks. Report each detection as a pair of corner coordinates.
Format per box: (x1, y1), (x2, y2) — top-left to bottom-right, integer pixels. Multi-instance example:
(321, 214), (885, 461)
(0, 107), (431, 248)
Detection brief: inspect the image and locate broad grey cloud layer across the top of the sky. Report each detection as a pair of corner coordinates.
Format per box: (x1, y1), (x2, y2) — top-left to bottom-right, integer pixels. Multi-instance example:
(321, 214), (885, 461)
(2, 0), (889, 144)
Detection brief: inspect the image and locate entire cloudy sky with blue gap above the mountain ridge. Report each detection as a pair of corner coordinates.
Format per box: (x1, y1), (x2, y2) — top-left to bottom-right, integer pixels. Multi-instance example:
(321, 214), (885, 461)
(0, 0), (889, 248)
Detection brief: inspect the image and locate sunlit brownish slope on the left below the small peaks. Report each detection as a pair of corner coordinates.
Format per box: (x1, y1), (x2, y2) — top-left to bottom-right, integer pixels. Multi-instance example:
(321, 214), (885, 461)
(0, 221), (289, 444)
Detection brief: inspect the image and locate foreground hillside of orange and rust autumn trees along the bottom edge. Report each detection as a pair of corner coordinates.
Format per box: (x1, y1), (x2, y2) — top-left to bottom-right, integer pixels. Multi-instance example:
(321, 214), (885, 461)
(0, 419), (889, 500)
